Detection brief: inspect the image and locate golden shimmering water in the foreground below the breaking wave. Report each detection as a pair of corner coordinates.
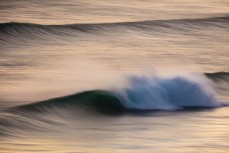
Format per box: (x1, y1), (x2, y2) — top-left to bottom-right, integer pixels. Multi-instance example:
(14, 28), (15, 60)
(1, 108), (229, 153)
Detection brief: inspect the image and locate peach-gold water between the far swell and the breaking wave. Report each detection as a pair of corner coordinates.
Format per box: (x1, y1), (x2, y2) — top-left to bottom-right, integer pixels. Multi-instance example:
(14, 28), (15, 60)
(0, 24), (229, 104)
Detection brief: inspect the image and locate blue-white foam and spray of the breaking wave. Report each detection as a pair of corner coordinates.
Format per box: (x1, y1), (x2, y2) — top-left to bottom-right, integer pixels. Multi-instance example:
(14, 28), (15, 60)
(116, 74), (223, 110)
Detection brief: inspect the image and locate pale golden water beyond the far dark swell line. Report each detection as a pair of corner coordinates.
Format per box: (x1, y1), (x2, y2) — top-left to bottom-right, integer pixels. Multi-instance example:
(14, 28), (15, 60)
(0, 0), (229, 24)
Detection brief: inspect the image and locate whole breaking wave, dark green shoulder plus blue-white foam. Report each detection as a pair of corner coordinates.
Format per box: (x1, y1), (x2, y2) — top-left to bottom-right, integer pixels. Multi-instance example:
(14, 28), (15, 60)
(8, 75), (224, 115)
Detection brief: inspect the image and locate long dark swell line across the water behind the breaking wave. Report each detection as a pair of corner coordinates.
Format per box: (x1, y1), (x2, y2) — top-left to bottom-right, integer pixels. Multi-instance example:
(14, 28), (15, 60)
(0, 16), (229, 35)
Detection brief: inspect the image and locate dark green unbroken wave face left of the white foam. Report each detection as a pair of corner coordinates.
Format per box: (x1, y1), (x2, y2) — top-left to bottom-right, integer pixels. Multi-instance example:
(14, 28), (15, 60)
(11, 90), (125, 114)
